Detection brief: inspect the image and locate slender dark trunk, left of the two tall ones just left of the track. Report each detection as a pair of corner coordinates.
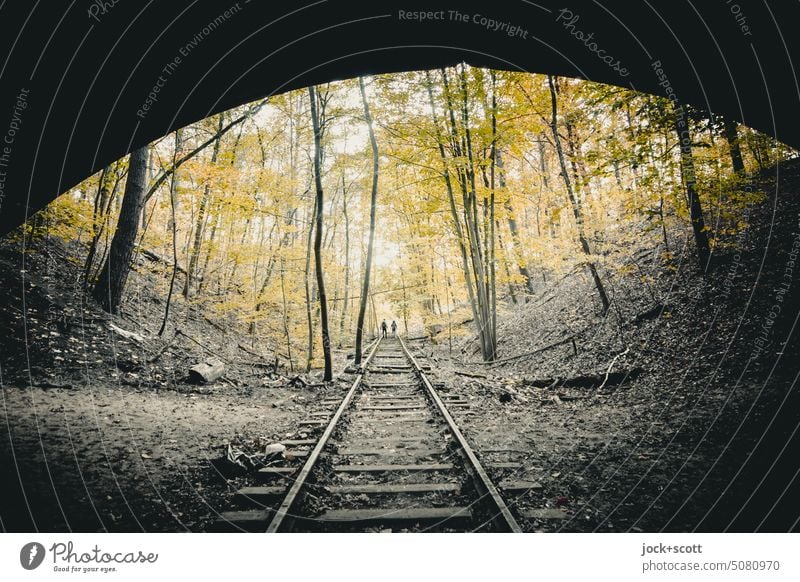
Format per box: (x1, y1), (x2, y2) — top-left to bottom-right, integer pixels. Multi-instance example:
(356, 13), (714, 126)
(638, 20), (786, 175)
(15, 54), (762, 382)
(308, 85), (333, 382)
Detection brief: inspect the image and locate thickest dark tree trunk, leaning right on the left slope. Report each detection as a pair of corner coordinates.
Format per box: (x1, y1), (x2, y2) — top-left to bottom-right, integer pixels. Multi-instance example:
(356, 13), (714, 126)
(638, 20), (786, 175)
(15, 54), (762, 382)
(92, 146), (150, 313)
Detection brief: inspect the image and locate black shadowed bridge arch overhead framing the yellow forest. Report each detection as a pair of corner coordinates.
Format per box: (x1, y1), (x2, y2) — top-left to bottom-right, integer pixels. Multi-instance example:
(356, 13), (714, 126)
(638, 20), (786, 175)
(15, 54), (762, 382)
(0, 0), (800, 232)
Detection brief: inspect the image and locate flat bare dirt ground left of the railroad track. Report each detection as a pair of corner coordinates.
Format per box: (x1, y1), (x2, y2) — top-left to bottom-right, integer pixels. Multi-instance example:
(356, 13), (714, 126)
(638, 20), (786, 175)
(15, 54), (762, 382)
(0, 386), (322, 531)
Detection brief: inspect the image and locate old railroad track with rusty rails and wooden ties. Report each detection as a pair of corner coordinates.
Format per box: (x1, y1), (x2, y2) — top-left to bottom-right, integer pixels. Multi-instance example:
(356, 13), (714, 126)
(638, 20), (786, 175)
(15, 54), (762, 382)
(215, 338), (521, 532)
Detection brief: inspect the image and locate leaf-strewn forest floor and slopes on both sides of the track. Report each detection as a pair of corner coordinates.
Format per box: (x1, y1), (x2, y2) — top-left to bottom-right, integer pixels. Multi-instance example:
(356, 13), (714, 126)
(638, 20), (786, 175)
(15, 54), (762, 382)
(0, 165), (800, 531)
